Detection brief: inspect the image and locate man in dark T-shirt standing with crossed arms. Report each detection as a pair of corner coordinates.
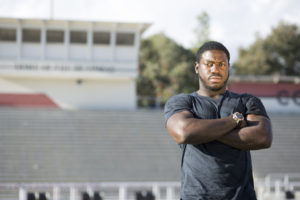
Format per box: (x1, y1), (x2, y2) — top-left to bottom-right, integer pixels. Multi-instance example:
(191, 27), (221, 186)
(164, 41), (272, 200)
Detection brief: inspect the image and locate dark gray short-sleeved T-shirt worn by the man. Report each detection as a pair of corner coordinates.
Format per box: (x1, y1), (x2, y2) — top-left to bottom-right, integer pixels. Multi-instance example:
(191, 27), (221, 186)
(164, 91), (268, 200)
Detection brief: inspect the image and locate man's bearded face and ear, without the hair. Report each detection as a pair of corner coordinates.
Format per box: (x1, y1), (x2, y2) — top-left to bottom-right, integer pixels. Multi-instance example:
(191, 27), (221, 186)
(195, 50), (229, 92)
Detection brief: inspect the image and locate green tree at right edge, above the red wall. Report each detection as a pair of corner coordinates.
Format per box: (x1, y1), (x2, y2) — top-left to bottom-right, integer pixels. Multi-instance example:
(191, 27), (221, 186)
(234, 22), (300, 76)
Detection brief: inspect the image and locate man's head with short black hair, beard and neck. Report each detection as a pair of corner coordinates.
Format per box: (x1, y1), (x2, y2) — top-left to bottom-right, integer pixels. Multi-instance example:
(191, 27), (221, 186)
(195, 41), (230, 94)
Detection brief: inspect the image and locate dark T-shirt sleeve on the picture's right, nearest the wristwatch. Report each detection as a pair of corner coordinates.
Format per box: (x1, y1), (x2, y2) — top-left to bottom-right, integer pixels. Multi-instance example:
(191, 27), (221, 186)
(244, 95), (269, 118)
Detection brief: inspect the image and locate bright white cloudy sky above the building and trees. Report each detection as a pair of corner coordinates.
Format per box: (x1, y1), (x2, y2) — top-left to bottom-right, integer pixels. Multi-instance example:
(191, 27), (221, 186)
(0, 0), (300, 62)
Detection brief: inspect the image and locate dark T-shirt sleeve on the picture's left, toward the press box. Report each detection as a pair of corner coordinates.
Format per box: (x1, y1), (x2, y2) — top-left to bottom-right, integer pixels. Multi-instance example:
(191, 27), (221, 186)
(164, 94), (193, 123)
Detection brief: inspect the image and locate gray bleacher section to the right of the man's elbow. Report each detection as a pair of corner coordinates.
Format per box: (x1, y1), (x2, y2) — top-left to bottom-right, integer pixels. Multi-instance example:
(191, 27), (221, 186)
(252, 113), (300, 177)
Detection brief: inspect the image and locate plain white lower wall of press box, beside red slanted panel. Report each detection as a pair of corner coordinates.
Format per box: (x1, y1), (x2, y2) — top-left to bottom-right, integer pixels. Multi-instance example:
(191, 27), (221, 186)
(0, 78), (136, 110)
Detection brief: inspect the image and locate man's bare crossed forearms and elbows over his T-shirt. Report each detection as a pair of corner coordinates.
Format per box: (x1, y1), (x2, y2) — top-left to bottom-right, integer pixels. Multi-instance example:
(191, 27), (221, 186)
(166, 110), (272, 150)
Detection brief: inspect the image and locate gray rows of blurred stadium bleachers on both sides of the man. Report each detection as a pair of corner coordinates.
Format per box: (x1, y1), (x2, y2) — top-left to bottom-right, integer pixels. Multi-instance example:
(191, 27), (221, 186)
(0, 108), (300, 199)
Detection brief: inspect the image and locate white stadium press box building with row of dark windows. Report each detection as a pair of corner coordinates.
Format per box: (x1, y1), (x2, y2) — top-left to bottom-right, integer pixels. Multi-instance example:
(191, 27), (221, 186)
(0, 18), (150, 110)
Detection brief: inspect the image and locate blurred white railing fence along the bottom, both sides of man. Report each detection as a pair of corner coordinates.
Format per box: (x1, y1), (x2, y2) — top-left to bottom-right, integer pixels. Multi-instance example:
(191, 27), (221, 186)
(0, 173), (300, 200)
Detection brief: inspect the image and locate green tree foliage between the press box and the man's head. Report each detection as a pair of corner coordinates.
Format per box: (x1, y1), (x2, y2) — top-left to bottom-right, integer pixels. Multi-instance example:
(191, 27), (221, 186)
(137, 33), (198, 106)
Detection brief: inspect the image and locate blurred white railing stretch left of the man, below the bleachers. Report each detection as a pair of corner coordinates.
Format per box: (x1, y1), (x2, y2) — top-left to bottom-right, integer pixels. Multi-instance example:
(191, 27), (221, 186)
(0, 182), (180, 200)
